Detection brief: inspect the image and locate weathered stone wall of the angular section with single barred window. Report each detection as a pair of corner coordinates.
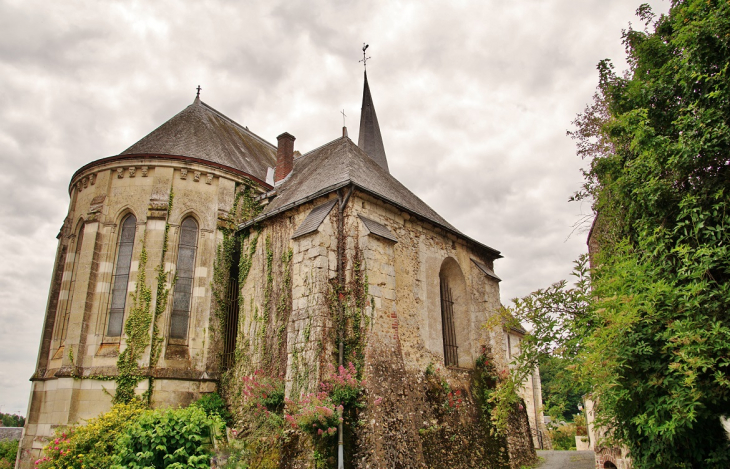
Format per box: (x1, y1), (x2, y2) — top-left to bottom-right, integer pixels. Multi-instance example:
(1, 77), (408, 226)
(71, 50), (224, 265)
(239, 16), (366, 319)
(219, 191), (535, 468)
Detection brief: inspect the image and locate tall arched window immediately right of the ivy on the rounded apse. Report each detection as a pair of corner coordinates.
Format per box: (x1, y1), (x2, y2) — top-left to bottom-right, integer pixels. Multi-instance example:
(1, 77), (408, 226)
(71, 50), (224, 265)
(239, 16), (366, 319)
(170, 217), (198, 339)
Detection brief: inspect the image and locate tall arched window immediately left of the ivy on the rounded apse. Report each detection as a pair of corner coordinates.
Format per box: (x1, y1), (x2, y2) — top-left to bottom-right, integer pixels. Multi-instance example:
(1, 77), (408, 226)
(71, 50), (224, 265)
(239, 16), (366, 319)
(106, 215), (137, 337)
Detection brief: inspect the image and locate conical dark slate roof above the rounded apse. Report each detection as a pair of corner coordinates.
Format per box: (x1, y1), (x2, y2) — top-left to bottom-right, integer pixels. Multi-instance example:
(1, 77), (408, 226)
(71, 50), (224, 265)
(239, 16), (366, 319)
(120, 98), (276, 180)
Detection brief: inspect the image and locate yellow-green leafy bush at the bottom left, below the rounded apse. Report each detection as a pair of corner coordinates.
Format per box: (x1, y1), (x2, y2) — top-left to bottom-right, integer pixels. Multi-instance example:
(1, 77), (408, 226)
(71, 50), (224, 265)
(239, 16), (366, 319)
(36, 399), (145, 469)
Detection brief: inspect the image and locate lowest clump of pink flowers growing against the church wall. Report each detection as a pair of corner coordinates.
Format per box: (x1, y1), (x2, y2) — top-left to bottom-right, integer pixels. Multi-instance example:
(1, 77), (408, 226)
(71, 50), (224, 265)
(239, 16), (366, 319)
(284, 391), (344, 437)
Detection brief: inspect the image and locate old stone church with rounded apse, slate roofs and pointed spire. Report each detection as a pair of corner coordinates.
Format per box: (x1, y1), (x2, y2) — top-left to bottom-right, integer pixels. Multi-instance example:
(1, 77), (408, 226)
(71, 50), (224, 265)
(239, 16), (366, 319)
(19, 70), (544, 468)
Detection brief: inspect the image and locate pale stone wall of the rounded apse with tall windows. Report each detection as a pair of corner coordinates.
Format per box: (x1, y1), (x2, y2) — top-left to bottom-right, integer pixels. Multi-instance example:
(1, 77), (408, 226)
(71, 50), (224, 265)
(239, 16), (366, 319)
(20, 160), (250, 468)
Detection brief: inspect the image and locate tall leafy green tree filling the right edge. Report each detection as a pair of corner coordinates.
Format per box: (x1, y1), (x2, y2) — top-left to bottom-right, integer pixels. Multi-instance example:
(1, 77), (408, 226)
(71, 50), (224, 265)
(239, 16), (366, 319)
(500, 0), (730, 468)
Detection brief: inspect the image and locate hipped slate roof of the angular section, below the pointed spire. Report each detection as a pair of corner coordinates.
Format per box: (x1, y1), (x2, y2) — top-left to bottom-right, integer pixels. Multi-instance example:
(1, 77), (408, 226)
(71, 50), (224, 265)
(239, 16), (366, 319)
(239, 137), (500, 257)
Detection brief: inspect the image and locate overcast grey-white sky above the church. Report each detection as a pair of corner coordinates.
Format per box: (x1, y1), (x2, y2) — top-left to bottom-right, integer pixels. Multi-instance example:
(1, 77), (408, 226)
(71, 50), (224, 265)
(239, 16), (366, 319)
(0, 0), (669, 415)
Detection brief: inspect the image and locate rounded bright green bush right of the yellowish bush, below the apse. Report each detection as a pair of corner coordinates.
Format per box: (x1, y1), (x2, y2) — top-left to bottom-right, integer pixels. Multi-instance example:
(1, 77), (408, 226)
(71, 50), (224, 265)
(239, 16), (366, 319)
(111, 406), (222, 469)
